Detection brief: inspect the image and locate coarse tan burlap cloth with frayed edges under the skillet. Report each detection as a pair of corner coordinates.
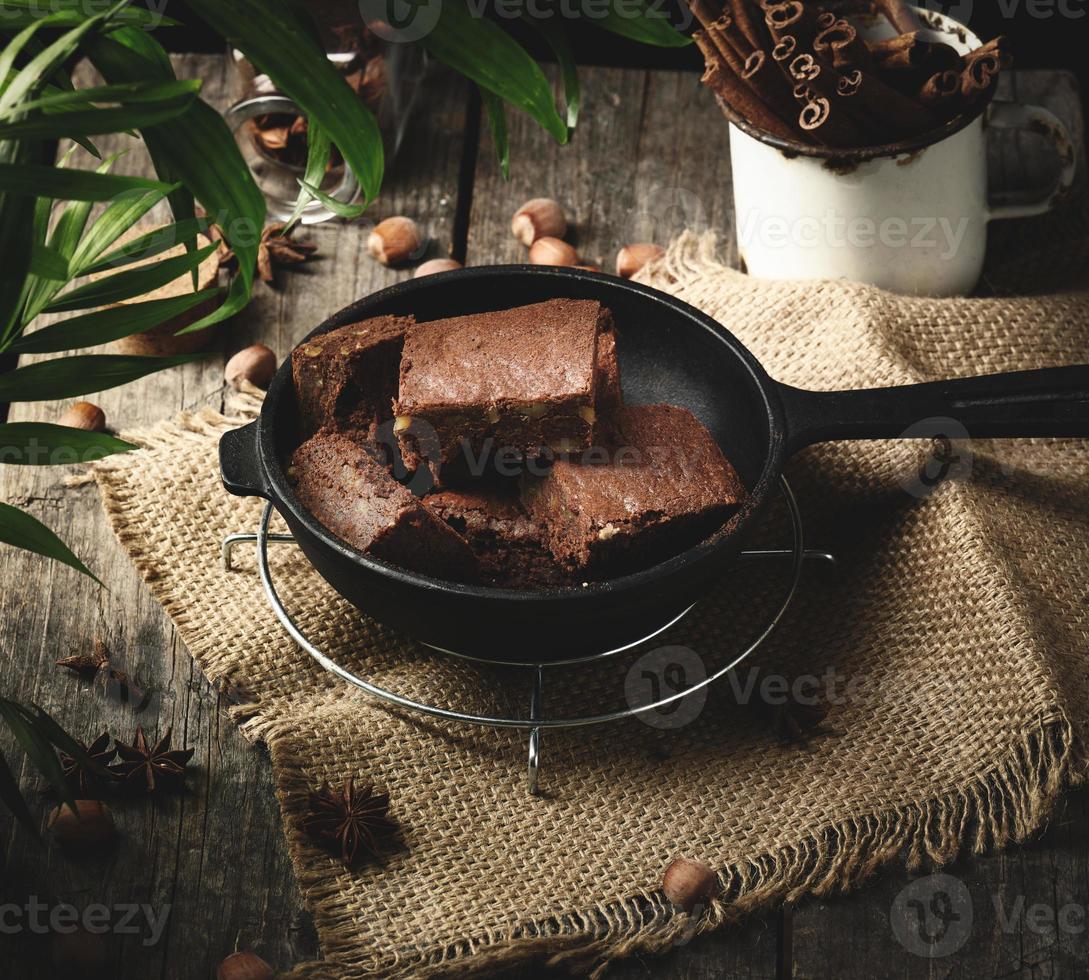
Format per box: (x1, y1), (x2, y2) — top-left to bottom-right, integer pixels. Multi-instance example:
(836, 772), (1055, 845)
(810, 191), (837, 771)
(97, 212), (1089, 977)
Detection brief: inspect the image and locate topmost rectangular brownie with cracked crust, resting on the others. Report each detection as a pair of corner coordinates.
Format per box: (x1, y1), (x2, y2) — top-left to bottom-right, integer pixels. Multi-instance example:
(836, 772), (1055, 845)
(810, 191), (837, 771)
(395, 299), (612, 476)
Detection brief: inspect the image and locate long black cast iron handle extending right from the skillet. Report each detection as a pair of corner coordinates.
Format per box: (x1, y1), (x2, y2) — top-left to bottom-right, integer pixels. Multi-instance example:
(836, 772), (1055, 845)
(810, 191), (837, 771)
(779, 365), (1089, 452)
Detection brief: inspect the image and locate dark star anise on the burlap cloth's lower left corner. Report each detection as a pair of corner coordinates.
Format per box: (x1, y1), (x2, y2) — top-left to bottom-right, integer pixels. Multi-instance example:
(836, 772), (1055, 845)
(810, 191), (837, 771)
(303, 776), (397, 868)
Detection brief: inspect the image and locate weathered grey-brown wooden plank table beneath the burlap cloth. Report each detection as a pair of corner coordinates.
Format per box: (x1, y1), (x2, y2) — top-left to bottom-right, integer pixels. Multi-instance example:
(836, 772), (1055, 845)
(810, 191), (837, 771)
(0, 57), (1089, 980)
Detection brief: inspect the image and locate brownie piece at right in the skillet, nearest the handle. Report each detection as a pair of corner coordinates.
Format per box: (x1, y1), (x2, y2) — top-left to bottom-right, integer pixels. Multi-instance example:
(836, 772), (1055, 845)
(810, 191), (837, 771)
(522, 405), (745, 578)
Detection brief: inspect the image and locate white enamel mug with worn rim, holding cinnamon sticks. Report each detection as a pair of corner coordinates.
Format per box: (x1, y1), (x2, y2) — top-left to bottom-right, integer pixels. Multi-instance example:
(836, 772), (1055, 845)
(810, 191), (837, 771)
(730, 9), (1075, 296)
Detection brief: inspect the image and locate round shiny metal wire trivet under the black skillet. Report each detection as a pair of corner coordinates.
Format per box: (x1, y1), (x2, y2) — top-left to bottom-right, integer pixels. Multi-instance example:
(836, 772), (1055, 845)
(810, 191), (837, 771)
(222, 478), (835, 795)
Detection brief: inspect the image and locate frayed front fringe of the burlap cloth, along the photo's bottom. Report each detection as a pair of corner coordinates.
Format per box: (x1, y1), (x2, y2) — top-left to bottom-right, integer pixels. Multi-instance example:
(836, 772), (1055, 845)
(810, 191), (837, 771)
(270, 718), (1078, 980)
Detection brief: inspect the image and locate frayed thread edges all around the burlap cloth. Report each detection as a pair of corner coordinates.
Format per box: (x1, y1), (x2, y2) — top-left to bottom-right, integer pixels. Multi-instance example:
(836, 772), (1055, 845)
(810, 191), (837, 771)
(90, 278), (1086, 980)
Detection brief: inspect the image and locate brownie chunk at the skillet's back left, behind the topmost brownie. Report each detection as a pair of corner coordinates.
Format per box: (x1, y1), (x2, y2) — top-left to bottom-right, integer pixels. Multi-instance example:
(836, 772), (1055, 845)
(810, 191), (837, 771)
(291, 317), (415, 439)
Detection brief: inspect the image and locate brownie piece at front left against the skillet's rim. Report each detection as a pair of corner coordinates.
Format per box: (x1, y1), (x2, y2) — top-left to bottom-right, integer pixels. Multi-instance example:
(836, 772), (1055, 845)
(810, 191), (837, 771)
(287, 429), (478, 581)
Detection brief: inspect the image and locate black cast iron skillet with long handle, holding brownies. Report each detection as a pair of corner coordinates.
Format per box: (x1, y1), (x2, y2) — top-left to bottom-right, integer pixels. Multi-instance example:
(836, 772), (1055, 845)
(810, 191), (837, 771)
(220, 266), (1089, 662)
